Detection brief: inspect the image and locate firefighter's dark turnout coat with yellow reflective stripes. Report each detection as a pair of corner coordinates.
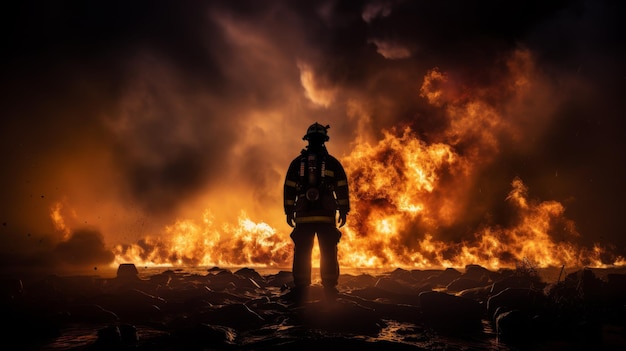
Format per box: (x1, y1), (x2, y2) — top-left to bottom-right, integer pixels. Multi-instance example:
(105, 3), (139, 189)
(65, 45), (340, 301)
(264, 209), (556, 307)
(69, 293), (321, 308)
(283, 148), (350, 225)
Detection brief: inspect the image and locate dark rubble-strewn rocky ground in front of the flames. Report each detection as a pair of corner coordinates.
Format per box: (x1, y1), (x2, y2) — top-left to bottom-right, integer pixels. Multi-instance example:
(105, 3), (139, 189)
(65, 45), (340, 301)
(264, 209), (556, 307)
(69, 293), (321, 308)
(0, 264), (626, 350)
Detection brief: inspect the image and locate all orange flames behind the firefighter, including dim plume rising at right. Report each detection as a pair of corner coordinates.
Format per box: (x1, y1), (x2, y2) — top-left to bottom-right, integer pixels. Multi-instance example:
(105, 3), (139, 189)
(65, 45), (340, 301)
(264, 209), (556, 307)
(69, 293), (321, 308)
(52, 51), (626, 269)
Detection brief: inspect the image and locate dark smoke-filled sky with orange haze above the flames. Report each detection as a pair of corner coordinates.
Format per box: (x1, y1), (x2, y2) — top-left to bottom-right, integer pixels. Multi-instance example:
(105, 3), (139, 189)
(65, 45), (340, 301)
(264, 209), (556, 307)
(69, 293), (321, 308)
(0, 0), (626, 267)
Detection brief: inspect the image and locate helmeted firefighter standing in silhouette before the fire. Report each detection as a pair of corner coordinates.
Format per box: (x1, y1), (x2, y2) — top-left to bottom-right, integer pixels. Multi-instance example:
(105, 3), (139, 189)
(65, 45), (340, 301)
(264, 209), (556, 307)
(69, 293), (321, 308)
(283, 122), (350, 302)
